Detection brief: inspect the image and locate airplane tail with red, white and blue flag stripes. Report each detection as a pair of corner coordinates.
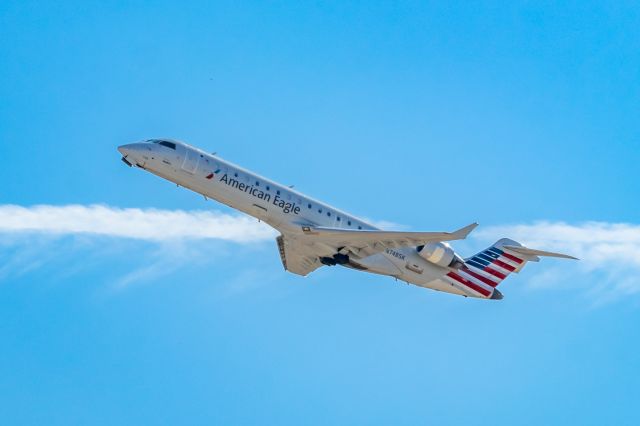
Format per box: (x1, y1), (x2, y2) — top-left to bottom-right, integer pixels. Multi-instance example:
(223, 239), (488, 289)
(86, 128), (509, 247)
(447, 238), (576, 299)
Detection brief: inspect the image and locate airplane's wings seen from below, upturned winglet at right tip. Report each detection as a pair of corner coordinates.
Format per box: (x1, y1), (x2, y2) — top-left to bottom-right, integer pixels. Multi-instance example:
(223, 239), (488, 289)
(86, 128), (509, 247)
(277, 223), (478, 275)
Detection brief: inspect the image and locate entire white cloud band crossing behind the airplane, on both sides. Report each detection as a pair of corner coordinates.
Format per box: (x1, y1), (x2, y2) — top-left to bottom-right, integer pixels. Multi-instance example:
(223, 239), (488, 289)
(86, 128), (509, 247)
(0, 205), (640, 303)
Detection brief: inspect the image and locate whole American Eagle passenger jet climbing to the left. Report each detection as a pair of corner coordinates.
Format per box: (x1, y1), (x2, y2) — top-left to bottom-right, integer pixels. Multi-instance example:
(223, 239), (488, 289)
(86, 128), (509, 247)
(118, 139), (576, 300)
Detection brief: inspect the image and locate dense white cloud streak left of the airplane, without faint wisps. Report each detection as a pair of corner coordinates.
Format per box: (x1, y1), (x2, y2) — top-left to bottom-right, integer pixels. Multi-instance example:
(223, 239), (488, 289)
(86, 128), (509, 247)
(0, 205), (276, 243)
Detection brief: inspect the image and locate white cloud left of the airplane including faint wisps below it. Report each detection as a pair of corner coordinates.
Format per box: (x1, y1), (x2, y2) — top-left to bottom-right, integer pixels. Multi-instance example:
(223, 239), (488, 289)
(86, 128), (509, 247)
(0, 205), (276, 290)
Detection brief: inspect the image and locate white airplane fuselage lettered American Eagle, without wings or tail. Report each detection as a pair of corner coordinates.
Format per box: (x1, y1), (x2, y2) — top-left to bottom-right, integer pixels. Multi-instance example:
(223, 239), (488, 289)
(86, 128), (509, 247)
(119, 140), (465, 295)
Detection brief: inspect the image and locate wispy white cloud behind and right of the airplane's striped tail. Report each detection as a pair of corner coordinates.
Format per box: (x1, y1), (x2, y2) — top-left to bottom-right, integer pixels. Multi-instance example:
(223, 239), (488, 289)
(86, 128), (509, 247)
(474, 222), (640, 304)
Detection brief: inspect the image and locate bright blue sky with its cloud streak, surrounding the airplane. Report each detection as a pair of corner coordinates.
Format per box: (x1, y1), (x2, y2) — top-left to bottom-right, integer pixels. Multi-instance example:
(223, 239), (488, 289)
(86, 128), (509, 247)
(0, 1), (640, 425)
